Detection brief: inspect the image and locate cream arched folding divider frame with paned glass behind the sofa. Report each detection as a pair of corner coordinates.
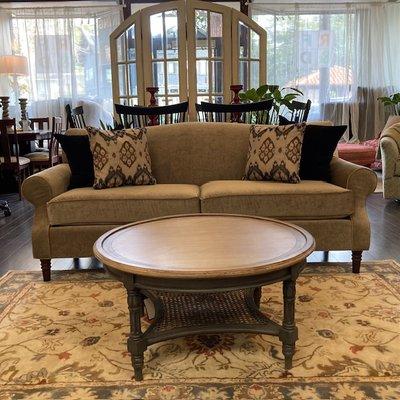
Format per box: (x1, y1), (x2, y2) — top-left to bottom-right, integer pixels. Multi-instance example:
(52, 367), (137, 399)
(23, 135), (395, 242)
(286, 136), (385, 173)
(110, 0), (266, 120)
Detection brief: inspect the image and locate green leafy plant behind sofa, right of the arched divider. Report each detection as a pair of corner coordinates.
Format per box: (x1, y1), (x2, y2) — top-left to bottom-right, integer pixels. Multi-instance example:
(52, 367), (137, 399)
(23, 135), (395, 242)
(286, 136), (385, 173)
(239, 85), (303, 123)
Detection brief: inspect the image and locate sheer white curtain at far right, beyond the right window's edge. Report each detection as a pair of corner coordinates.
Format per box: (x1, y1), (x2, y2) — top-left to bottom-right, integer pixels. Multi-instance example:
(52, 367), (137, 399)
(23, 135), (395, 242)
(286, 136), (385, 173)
(352, 3), (400, 140)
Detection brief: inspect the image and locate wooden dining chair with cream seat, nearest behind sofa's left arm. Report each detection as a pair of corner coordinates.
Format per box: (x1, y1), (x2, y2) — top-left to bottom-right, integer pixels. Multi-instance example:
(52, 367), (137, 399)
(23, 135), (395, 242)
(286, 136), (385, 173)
(25, 117), (62, 173)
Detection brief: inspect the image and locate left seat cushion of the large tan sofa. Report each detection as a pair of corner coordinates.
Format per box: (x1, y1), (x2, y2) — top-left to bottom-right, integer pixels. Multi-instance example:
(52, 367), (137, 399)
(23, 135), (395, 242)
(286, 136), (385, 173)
(47, 184), (200, 226)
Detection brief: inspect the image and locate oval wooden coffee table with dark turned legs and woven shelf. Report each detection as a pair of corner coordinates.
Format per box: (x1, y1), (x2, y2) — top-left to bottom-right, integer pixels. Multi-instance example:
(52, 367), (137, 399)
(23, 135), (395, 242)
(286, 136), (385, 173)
(94, 214), (315, 380)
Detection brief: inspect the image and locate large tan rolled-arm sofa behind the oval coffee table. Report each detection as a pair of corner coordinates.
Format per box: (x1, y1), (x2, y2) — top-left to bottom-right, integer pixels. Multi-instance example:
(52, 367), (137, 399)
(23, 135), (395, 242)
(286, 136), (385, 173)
(23, 123), (376, 279)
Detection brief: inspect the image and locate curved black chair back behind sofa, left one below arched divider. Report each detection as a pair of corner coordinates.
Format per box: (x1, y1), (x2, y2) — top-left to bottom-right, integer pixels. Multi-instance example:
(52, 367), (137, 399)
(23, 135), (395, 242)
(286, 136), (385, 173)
(114, 101), (189, 128)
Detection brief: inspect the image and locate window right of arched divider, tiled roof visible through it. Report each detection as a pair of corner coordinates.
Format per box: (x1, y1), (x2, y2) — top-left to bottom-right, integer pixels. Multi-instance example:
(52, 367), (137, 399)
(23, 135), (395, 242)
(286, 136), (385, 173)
(253, 11), (354, 119)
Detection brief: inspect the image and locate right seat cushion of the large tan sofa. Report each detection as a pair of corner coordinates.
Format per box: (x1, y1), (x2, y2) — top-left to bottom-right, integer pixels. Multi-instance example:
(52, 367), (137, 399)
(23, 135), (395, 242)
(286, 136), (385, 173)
(200, 181), (354, 220)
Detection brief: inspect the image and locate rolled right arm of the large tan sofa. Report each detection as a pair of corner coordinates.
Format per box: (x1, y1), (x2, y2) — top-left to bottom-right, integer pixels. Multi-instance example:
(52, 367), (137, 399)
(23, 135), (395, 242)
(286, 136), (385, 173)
(330, 157), (378, 198)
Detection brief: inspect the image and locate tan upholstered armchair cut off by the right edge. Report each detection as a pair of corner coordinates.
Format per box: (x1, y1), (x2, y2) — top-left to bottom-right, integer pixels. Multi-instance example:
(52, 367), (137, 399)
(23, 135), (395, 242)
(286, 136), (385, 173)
(380, 123), (400, 200)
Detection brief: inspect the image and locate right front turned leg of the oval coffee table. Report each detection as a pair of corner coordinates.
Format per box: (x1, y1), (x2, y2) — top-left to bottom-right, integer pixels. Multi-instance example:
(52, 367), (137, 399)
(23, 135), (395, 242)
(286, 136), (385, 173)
(279, 279), (298, 369)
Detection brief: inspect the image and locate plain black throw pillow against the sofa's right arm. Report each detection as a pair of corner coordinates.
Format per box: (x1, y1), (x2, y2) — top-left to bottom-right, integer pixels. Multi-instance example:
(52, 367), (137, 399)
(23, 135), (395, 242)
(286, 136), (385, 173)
(300, 125), (347, 181)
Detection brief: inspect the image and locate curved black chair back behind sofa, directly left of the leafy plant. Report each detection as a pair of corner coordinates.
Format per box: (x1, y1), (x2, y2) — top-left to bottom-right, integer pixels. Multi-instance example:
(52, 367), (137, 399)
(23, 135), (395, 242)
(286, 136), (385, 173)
(196, 99), (273, 125)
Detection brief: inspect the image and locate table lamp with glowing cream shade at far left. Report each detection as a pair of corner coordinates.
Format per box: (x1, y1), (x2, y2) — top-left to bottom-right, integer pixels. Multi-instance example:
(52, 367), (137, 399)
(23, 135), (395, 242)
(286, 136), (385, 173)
(0, 55), (28, 119)
